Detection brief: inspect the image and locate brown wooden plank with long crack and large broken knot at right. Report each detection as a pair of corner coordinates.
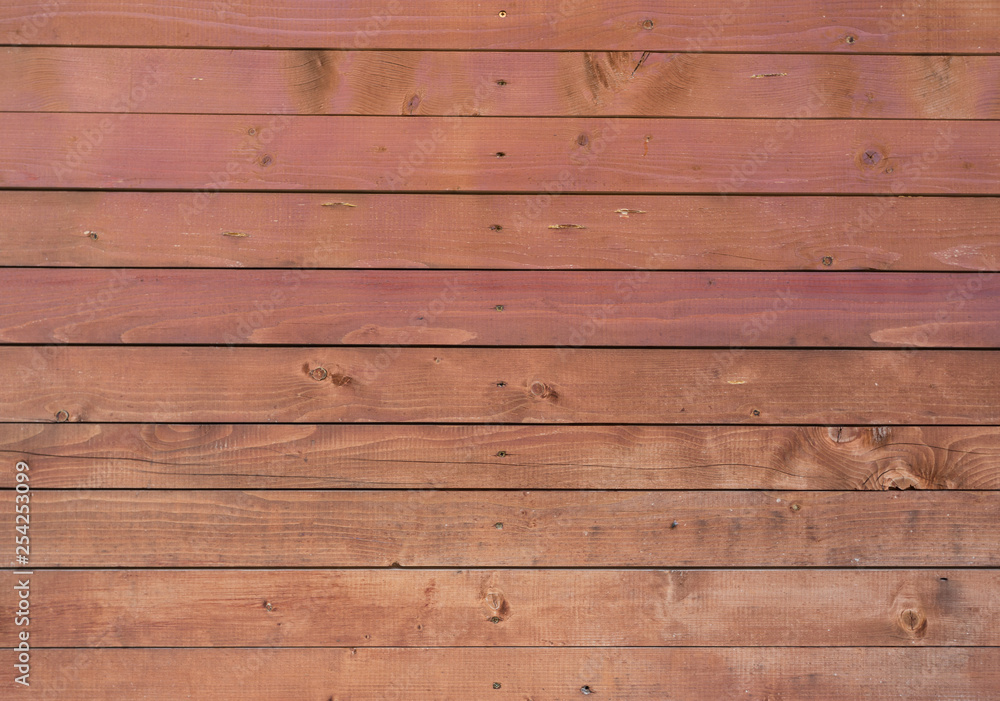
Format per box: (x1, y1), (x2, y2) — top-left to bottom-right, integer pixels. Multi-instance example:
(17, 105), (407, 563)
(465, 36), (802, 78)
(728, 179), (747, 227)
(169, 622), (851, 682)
(0, 424), (1000, 490)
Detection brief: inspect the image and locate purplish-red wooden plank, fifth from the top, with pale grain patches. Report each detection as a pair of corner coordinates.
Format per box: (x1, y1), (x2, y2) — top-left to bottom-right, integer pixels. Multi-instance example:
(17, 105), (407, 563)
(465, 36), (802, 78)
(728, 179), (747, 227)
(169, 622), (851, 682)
(0, 268), (1000, 348)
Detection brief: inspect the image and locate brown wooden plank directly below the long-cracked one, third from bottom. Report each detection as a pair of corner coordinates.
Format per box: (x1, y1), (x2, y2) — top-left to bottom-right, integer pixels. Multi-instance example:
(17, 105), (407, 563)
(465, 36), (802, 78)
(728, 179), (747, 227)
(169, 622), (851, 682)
(9, 490), (1000, 567)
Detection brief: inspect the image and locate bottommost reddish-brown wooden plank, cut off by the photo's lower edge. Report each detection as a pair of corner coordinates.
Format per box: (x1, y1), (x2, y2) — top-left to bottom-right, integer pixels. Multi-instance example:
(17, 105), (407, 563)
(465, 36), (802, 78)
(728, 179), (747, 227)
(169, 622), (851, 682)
(15, 648), (1000, 701)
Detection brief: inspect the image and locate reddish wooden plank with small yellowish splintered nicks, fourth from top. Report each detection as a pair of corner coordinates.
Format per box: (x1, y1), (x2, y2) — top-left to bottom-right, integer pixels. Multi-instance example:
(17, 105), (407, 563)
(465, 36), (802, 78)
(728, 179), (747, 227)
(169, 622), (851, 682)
(7, 190), (1000, 271)
